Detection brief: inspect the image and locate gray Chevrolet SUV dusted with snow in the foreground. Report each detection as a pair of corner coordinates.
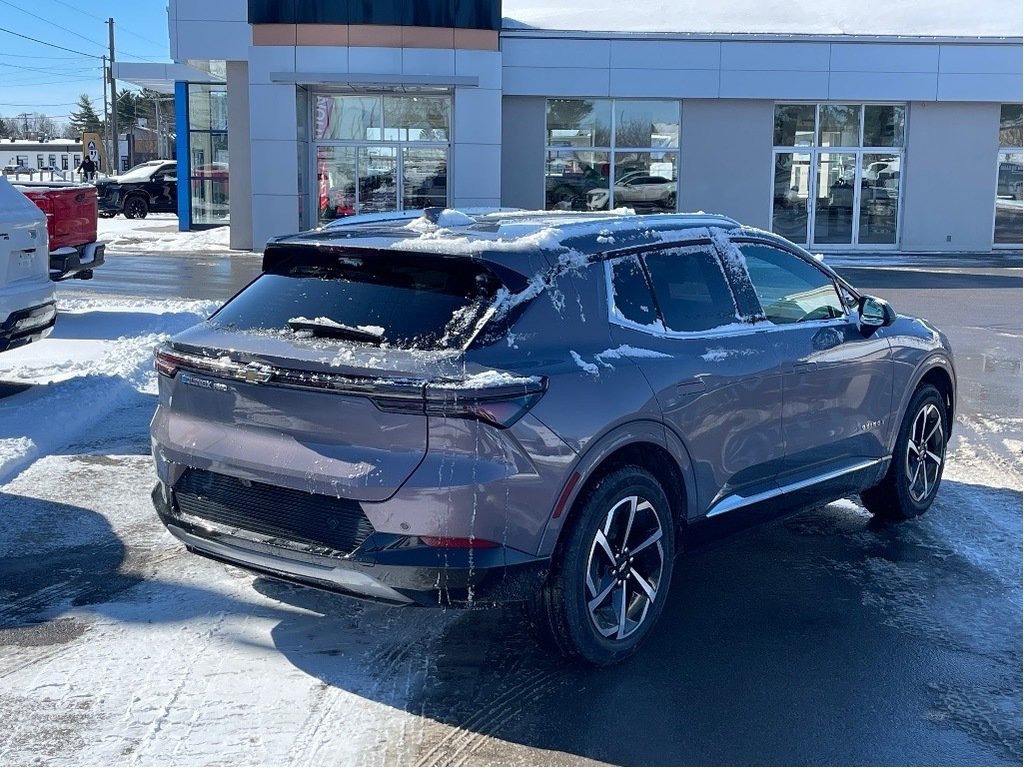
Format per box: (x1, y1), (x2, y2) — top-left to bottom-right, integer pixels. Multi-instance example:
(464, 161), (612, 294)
(152, 209), (956, 666)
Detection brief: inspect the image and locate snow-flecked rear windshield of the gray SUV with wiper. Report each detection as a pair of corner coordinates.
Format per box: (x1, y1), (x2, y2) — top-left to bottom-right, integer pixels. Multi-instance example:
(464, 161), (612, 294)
(210, 249), (502, 349)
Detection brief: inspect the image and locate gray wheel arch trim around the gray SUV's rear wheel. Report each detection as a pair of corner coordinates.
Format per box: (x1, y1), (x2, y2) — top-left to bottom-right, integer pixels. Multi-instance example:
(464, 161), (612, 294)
(538, 421), (696, 556)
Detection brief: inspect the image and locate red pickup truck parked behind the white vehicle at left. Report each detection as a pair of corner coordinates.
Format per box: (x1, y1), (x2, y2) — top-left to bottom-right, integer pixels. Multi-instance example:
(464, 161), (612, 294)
(15, 181), (103, 281)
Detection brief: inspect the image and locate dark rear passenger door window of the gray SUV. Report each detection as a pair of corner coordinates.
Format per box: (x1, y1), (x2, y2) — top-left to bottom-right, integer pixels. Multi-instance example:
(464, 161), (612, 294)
(644, 245), (737, 331)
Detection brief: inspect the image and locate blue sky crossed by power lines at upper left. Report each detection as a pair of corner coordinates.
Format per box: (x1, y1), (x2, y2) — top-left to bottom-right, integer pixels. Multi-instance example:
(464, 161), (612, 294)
(0, 0), (169, 123)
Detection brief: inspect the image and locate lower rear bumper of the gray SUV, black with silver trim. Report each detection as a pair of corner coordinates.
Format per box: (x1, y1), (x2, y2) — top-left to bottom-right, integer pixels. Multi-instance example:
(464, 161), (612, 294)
(153, 482), (549, 607)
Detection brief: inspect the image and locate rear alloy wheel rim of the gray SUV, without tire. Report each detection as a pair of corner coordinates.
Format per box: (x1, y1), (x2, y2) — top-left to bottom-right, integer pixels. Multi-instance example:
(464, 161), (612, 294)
(586, 496), (665, 640)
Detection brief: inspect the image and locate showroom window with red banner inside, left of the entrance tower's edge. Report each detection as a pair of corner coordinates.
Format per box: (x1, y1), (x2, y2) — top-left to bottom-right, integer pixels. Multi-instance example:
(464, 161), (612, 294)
(313, 94), (452, 221)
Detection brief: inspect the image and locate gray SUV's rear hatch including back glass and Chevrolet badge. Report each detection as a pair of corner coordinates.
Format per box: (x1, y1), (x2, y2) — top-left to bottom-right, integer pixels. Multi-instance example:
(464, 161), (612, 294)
(154, 246), (524, 501)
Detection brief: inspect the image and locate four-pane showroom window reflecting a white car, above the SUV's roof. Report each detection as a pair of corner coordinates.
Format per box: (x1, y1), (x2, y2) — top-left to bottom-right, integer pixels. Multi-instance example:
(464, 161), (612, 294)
(544, 98), (680, 212)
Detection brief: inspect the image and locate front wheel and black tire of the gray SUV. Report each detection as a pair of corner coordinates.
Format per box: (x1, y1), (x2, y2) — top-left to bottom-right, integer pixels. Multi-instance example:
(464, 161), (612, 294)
(860, 384), (949, 520)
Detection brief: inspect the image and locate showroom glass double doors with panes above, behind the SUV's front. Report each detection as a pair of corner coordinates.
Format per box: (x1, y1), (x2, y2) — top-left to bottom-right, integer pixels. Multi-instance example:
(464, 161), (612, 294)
(772, 104), (906, 246)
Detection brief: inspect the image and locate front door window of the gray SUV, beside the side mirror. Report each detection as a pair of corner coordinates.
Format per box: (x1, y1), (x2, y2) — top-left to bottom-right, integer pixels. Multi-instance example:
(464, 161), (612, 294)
(736, 243), (846, 325)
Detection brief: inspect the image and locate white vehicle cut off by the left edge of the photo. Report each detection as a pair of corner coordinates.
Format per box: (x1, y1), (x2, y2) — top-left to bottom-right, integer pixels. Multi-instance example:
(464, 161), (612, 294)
(0, 178), (57, 352)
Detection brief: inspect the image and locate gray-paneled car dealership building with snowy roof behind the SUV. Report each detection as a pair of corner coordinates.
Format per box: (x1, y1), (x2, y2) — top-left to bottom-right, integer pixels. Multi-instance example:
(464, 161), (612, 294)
(117, 0), (1024, 252)
